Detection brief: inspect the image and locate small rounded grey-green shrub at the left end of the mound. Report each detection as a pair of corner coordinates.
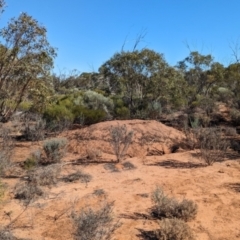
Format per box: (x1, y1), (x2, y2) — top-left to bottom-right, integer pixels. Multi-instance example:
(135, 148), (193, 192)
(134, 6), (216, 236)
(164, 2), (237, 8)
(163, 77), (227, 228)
(40, 138), (67, 164)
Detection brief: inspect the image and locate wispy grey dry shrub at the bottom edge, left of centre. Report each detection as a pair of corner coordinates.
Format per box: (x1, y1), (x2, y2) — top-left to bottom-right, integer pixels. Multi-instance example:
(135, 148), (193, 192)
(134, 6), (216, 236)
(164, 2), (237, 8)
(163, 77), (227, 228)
(72, 202), (119, 240)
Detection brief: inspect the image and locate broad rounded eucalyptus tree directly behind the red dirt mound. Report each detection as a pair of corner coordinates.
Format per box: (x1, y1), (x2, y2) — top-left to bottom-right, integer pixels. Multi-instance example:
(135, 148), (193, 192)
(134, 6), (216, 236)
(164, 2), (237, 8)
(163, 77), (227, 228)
(99, 49), (184, 116)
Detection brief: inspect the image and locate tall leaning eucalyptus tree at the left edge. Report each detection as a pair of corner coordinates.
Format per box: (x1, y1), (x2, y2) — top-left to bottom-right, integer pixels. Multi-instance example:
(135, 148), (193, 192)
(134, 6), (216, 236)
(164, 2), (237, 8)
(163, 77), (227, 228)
(0, 11), (56, 121)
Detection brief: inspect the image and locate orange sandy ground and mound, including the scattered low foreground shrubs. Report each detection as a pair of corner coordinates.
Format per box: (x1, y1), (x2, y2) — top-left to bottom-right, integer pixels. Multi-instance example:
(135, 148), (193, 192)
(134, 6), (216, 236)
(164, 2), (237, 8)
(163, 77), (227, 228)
(0, 120), (240, 240)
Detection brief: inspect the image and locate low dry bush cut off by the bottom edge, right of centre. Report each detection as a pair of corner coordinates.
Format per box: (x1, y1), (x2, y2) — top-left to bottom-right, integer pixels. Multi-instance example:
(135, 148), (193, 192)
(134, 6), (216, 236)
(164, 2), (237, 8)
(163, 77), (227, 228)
(156, 219), (195, 240)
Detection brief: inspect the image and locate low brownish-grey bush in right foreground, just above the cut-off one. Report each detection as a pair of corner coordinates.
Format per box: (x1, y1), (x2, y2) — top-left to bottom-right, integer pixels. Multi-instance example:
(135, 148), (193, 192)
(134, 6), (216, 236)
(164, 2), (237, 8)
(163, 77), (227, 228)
(152, 187), (197, 221)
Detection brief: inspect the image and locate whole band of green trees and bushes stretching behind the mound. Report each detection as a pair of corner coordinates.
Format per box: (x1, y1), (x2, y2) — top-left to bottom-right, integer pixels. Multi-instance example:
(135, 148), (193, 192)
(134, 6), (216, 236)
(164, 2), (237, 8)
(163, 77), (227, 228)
(0, 0), (240, 126)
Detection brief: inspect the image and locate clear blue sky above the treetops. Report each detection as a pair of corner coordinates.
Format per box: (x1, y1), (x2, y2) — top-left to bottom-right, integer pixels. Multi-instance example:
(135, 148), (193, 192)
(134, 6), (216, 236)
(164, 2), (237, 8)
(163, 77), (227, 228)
(0, 0), (240, 73)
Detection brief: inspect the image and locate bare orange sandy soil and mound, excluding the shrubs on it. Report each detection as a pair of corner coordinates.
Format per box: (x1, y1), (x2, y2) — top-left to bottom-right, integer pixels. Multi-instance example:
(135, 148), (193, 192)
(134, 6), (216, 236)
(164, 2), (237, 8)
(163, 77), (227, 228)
(0, 120), (240, 240)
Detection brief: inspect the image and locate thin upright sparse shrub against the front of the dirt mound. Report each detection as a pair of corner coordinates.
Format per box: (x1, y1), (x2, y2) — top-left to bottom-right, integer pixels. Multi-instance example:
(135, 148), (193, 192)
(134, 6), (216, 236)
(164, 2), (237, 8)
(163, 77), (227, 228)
(110, 125), (133, 162)
